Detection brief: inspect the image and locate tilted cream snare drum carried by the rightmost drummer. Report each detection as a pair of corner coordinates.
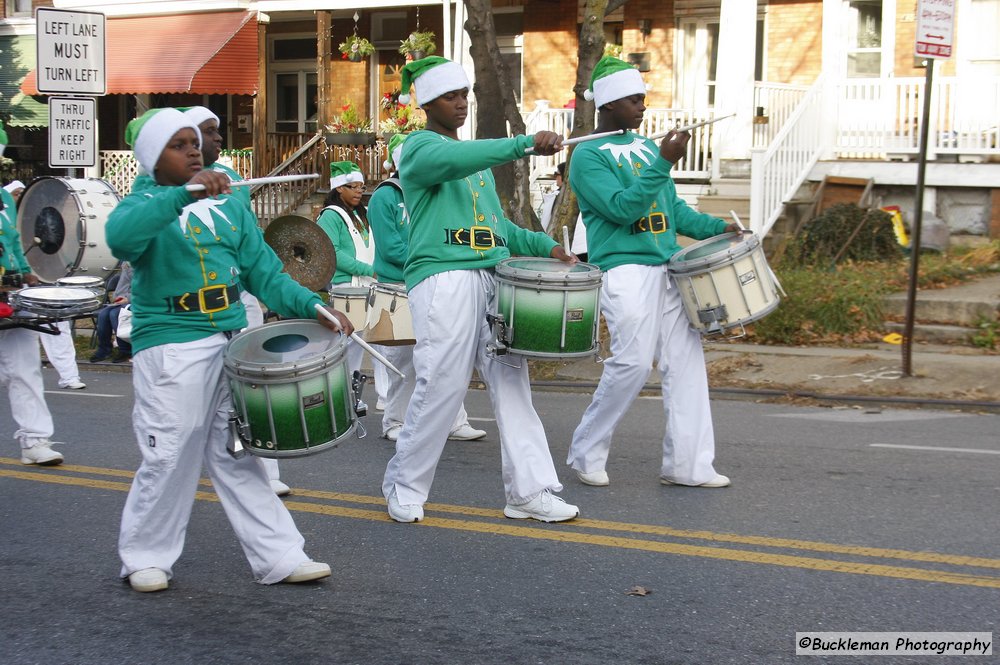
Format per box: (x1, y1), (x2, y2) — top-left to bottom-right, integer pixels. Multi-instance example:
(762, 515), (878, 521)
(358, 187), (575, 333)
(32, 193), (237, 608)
(667, 232), (780, 337)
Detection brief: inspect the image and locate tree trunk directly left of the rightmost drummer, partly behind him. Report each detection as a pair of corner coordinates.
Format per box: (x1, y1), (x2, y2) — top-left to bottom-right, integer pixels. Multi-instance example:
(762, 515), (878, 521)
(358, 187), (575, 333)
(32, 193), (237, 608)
(552, 0), (612, 248)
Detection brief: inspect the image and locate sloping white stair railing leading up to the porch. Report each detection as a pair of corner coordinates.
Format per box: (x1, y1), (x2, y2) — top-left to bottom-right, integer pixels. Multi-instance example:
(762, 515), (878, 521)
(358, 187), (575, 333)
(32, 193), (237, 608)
(750, 77), (825, 238)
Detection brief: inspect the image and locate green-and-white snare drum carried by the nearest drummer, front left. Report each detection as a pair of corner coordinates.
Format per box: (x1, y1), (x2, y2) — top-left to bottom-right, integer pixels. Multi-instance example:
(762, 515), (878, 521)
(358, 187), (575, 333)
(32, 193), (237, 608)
(224, 319), (357, 458)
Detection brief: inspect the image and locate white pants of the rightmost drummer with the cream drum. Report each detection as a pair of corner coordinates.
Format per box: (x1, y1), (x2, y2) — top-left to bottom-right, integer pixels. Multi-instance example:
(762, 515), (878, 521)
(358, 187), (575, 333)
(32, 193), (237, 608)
(566, 264), (716, 485)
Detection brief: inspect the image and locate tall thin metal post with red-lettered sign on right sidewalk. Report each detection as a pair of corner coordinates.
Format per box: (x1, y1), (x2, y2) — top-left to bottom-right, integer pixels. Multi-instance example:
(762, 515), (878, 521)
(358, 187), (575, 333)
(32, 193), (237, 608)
(903, 0), (955, 376)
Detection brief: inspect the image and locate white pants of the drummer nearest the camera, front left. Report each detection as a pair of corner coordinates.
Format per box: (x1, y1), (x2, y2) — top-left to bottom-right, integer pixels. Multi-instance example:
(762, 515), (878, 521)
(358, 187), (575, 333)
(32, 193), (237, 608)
(118, 333), (309, 584)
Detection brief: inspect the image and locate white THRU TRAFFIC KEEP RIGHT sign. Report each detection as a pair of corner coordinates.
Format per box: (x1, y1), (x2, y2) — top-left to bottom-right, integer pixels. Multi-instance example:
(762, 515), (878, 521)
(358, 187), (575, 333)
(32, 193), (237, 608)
(49, 97), (97, 168)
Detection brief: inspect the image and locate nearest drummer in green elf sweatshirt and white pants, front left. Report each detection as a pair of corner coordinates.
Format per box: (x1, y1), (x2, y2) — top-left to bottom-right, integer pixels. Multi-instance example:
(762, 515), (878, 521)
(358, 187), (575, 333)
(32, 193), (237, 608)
(105, 108), (352, 592)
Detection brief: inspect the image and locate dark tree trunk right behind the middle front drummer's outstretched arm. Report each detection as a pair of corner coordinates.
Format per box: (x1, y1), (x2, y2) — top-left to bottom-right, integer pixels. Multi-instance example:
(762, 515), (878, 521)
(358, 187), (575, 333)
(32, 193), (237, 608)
(465, 0), (544, 231)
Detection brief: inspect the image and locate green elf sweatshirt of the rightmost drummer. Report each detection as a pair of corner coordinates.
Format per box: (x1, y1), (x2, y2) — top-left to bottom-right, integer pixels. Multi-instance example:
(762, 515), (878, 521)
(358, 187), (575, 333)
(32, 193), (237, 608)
(569, 132), (727, 270)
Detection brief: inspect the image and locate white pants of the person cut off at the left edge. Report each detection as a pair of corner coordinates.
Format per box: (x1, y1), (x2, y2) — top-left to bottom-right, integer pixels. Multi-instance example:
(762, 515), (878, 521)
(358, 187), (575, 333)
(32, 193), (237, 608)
(0, 328), (53, 448)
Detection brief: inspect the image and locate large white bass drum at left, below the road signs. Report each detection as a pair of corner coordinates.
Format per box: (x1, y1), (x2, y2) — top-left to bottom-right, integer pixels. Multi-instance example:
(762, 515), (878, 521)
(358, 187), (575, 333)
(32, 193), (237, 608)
(17, 176), (121, 283)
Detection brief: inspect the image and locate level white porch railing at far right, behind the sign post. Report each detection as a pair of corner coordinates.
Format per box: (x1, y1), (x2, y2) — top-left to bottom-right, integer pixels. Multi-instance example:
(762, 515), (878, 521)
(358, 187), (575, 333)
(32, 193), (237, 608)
(834, 77), (1000, 159)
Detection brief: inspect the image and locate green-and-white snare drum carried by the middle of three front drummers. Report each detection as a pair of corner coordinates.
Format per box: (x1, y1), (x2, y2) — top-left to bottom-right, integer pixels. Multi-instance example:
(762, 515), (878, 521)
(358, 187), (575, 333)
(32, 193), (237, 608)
(496, 258), (601, 359)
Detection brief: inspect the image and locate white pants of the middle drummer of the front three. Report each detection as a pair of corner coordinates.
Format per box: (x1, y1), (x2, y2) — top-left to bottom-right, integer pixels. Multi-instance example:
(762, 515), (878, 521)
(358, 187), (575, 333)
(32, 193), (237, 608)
(382, 270), (562, 505)
